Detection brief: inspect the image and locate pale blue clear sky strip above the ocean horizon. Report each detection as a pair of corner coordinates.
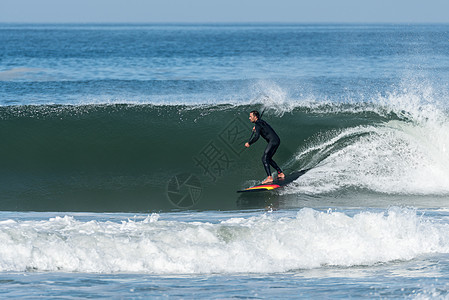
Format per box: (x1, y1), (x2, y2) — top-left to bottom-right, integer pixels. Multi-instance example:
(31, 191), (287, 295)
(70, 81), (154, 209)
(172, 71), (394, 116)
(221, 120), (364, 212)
(0, 0), (449, 23)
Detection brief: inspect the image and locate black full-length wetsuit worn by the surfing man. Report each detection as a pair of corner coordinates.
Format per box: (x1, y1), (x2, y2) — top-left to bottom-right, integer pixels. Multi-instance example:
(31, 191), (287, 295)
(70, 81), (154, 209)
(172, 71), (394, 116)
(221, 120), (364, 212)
(248, 120), (282, 176)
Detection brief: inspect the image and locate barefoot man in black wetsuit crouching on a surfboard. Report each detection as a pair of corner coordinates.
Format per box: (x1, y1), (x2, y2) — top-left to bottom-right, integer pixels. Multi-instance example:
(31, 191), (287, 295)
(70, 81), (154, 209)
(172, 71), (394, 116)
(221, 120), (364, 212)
(245, 110), (285, 184)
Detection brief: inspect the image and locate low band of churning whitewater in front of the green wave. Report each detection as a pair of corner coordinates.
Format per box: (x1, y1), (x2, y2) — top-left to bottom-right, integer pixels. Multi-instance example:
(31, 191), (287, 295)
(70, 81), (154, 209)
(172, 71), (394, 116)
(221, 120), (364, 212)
(0, 208), (449, 274)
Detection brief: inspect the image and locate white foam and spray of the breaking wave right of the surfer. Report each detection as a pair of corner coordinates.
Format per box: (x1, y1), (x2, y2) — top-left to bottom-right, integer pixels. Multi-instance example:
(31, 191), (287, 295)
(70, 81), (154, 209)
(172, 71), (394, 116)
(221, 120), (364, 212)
(285, 81), (449, 195)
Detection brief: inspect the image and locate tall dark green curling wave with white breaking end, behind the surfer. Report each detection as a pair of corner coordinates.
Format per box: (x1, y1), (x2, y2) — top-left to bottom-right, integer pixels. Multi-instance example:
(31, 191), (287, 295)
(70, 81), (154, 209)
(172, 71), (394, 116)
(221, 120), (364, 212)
(0, 89), (449, 212)
